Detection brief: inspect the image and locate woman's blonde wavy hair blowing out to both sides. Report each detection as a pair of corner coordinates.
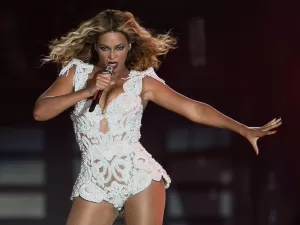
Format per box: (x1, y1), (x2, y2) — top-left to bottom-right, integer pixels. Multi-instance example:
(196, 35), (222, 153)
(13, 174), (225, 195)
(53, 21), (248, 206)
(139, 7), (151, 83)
(42, 10), (177, 70)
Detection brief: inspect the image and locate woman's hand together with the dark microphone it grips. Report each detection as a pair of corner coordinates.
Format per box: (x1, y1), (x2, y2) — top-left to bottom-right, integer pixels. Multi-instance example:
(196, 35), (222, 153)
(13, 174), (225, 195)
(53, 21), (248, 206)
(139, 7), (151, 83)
(87, 66), (114, 112)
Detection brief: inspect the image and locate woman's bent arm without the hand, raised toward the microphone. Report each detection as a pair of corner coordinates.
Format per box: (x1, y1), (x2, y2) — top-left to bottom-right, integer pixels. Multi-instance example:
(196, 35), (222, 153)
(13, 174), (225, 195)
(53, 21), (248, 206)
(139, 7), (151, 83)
(33, 66), (90, 121)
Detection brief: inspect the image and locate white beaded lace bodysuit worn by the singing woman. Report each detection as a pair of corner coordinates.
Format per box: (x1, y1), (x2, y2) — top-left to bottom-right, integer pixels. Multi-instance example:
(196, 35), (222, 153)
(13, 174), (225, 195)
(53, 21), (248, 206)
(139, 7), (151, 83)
(60, 59), (171, 210)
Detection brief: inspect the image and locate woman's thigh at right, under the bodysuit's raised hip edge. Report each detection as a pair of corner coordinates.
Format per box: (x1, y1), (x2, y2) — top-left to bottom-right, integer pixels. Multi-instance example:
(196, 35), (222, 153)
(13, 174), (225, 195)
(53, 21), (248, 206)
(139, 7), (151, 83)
(124, 180), (166, 225)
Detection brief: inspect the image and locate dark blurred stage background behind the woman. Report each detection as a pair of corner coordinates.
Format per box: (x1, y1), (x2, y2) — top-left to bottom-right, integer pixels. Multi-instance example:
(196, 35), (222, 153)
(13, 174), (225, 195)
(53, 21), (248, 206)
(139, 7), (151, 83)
(0, 0), (300, 225)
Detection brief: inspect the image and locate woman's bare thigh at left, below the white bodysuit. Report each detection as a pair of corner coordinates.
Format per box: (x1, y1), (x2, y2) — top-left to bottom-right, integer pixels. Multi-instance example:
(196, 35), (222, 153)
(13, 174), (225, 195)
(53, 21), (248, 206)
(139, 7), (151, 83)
(67, 197), (118, 225)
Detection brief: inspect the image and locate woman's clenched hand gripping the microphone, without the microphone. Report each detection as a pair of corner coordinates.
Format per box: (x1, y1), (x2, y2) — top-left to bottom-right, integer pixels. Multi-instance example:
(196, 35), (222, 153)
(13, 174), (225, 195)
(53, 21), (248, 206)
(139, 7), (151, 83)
(86, 71), (115, 96)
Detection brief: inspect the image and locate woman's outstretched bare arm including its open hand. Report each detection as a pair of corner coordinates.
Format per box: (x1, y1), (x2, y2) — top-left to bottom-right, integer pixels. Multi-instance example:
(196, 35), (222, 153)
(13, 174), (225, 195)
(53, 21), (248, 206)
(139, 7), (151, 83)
(143, 77), (281, 154)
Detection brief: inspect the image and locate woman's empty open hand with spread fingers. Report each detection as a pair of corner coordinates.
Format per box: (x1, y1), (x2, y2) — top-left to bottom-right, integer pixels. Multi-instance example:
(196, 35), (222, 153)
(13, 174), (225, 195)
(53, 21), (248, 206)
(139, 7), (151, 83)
(244, 118), (282, 155)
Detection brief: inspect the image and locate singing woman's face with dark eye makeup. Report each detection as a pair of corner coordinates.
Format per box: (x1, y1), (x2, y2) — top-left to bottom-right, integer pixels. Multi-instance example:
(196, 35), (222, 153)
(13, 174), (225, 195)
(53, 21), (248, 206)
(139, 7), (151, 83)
(95, 32), (129, 72)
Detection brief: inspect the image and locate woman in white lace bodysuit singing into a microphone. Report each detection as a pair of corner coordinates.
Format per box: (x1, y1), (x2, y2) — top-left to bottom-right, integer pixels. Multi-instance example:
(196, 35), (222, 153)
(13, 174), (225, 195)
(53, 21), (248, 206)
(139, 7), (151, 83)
(34, 10), (281, 225)
